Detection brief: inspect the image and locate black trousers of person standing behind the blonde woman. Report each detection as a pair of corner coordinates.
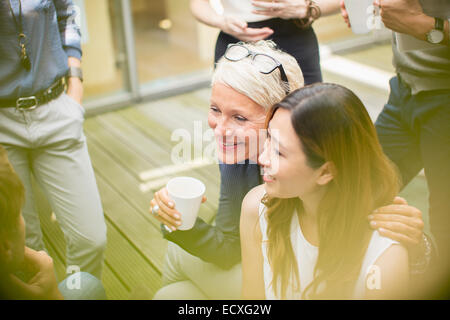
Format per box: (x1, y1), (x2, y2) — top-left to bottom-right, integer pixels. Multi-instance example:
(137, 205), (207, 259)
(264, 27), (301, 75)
(214, 18), (322, 85)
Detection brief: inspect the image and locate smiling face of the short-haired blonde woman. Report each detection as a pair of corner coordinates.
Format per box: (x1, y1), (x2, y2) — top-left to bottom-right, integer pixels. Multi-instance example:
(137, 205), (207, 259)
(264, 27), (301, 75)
(208, 83), (266, 164)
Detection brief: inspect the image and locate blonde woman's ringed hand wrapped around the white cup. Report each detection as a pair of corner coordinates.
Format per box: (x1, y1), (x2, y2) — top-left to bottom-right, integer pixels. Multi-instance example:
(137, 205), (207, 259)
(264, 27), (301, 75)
(149, 188), (206, 231)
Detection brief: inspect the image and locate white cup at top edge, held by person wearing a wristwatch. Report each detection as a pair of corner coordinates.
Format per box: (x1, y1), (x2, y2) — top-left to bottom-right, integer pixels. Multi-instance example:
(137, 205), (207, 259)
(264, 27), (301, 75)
(344, 0), (374, 34)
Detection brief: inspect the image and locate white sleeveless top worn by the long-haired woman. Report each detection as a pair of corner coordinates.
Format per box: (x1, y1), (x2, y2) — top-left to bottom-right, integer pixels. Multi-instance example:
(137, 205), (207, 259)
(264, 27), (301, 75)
(259, 203), (398, 300)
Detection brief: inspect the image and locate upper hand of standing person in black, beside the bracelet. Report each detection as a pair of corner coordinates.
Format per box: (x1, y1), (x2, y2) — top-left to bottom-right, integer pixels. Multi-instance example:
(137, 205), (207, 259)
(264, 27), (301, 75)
(252, 0), (308, 19)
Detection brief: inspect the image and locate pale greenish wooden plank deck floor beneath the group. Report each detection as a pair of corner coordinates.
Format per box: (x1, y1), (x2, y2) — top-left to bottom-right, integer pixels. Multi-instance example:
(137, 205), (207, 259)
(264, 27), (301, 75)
(35, 46), (427, 299)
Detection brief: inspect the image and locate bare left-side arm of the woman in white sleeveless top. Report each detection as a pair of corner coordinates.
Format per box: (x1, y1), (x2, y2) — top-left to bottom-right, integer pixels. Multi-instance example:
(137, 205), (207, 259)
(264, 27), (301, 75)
(240, 185), (266, 300)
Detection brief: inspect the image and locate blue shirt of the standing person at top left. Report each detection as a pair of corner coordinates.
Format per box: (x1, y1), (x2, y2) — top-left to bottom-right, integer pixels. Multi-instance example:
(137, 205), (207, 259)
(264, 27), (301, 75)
(0, 0), (82, 100)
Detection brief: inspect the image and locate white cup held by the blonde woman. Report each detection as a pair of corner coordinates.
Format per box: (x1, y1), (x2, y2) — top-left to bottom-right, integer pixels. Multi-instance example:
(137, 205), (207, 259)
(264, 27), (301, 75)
(166, 177), (206, 230)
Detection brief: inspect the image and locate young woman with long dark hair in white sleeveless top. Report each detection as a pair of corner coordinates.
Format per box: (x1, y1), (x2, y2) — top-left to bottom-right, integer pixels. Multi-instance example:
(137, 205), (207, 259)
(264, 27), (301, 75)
(240, 84), (409, 299)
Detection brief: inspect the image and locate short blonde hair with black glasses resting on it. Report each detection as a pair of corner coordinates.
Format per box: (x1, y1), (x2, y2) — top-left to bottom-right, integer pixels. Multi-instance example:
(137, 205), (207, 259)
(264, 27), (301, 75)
(211, 40), (304, 111)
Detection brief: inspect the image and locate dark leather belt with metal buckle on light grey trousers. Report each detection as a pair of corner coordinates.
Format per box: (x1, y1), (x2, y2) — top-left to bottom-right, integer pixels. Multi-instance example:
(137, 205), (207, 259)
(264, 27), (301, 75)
(0, 77), (65, 110)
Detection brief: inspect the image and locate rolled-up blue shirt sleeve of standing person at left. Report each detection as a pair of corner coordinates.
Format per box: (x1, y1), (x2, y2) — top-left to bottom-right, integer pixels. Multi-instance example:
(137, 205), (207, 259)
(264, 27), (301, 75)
(53, 0), (82, 60)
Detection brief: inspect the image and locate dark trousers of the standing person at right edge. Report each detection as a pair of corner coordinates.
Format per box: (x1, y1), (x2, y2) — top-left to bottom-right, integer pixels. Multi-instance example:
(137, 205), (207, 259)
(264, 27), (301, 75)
(375, 76), (450, 298)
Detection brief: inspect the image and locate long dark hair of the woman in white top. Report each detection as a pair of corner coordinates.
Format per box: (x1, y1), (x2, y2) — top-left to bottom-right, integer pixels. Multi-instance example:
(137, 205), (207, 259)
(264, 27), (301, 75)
(263, 83), (399, 299)
